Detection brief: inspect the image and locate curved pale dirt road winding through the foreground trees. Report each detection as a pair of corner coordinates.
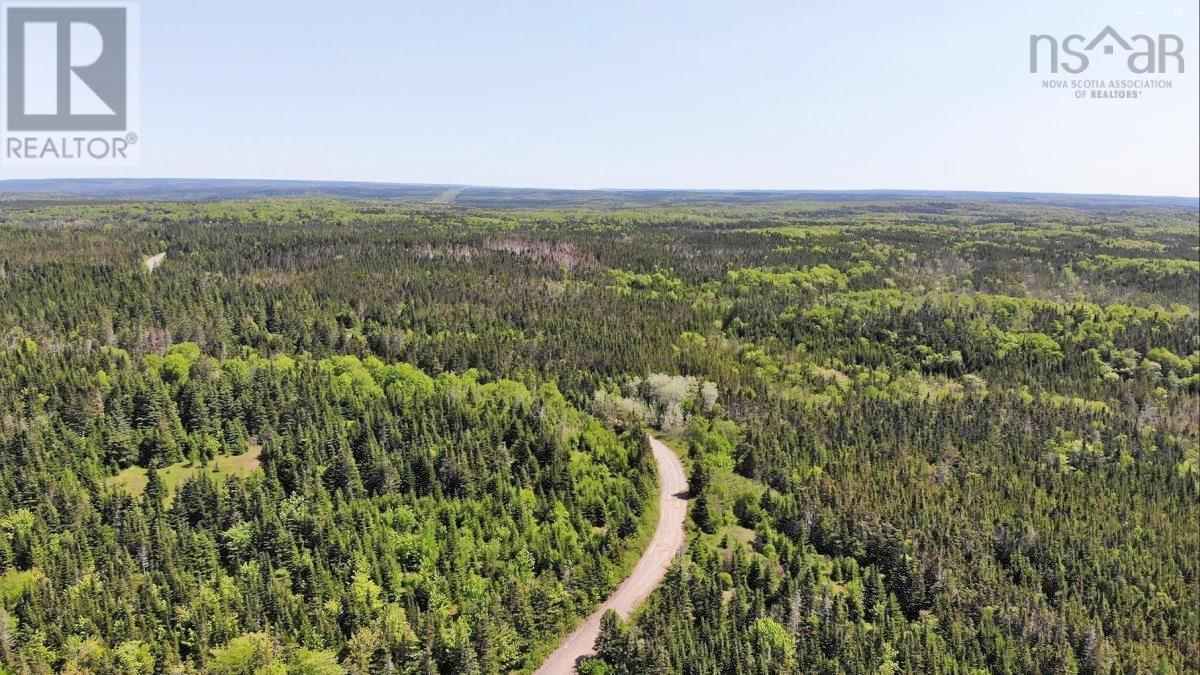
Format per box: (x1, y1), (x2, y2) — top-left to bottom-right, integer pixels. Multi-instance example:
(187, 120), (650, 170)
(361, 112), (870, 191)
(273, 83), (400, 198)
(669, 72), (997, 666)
(534, 436), (688, 675)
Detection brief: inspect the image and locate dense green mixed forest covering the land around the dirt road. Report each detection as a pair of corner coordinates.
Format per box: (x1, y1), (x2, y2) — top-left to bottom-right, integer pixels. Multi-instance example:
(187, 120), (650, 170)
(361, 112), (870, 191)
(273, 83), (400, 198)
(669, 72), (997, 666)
(0, 197), (1200, 675)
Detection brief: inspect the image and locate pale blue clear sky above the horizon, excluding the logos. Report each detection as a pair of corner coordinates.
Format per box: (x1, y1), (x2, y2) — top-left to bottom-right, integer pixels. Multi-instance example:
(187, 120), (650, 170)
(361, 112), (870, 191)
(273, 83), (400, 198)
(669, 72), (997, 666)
(0, 0), (1200, 197)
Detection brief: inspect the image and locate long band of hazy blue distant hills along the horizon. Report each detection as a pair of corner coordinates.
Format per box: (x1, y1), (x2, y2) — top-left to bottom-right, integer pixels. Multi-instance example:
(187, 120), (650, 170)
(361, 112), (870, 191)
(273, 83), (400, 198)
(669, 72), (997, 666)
(0, 178), (1200, 210)
